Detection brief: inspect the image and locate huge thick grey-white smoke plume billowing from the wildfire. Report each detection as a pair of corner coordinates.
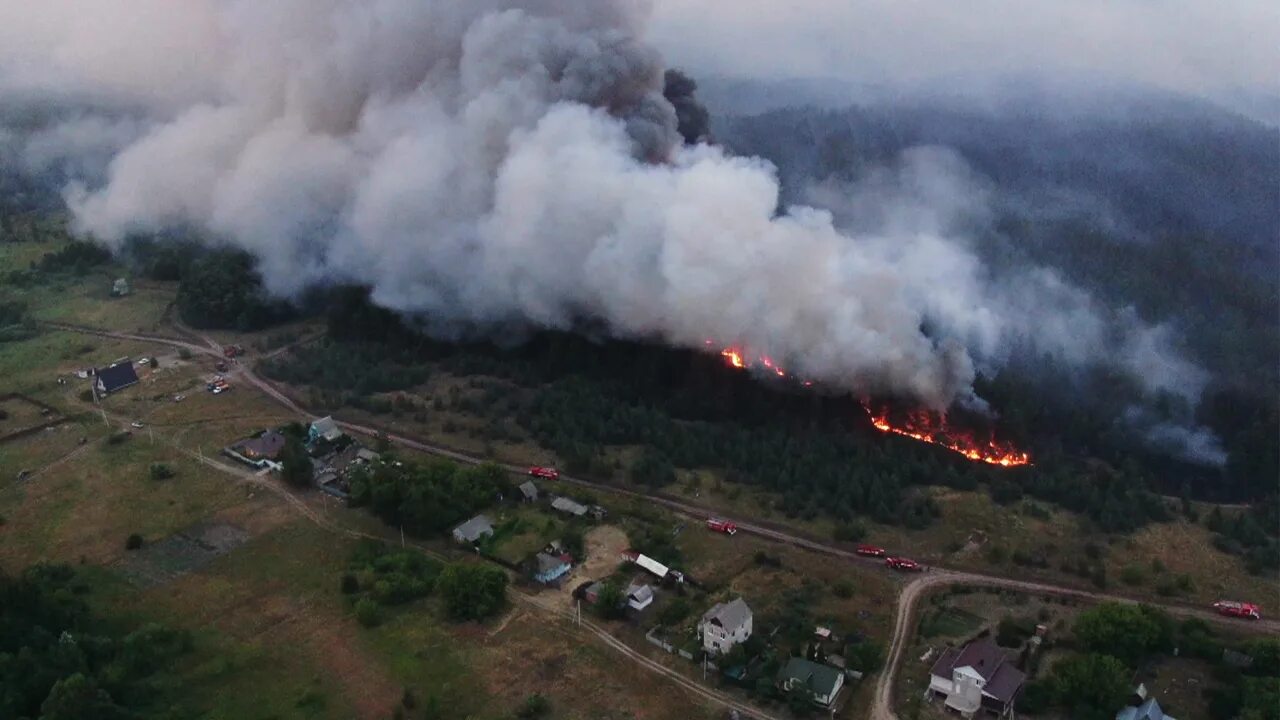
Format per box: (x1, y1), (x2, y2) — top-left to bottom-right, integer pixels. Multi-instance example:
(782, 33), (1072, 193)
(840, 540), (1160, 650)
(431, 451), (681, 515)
(0, 0), (1218, 453)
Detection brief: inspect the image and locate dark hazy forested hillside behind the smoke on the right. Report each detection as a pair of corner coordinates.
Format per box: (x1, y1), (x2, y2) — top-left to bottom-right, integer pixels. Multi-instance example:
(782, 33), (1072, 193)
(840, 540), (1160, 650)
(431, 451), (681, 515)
(713, 87), (1280, 500)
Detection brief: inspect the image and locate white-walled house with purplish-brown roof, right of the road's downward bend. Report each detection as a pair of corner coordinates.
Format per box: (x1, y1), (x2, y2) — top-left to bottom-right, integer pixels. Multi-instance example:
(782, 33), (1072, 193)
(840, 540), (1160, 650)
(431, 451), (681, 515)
(929, 637), (1027, 717)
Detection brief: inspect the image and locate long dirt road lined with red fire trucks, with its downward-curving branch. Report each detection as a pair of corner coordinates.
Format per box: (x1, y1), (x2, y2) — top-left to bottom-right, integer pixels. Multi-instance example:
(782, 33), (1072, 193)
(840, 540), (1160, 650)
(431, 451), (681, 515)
(46, 323), (1280, 720)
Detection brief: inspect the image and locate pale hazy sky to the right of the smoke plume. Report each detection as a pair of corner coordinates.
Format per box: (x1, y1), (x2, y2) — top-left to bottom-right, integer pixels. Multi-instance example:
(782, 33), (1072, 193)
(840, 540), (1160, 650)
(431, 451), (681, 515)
(649, 0), (1280, 97)
